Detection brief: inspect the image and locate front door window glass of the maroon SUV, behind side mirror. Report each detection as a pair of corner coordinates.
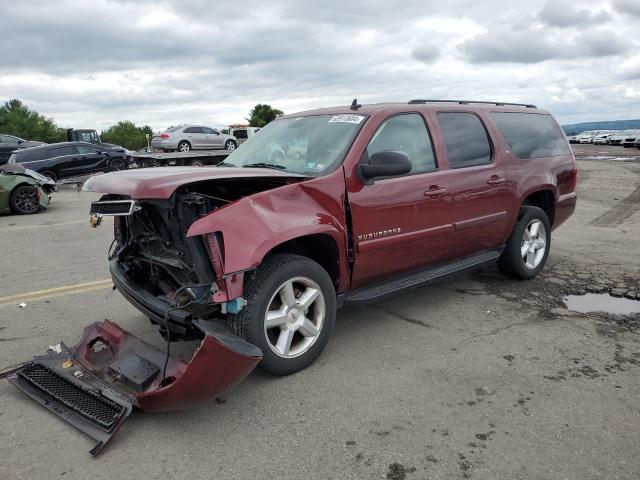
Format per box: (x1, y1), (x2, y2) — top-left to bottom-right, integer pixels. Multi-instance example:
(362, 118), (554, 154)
(367, 113), (436, 175)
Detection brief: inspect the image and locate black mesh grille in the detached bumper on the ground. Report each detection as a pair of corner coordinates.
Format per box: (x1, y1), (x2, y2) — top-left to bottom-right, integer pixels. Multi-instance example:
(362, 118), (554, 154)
(18, 363), (124, 431)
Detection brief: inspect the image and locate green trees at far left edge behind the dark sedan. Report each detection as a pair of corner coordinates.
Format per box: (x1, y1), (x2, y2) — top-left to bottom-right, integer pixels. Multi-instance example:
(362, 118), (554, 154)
(0, 98), (66, 142)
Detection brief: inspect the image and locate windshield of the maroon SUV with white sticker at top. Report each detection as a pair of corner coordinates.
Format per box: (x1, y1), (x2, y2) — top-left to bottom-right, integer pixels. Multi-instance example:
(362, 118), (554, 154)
(225, 114), (365, 177)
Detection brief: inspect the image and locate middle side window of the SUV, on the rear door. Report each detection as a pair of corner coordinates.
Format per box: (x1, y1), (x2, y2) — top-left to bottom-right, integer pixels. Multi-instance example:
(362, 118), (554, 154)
(436, 112), (491, 168)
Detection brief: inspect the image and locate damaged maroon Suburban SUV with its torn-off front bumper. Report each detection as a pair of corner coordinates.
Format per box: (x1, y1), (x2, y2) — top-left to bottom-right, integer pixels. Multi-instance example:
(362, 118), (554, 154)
(0, 100), (576, 450)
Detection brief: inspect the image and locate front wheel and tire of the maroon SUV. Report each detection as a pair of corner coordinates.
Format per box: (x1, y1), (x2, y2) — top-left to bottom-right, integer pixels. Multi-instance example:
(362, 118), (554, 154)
(229, 254), (336, 375)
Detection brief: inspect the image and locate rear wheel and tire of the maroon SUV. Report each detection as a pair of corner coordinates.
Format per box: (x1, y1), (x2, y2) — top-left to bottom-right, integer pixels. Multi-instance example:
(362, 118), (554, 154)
(498, 206), (551, 280)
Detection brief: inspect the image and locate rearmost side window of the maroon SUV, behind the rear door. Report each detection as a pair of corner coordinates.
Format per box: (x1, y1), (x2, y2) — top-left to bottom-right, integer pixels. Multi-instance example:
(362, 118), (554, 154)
(491, 112), (569, 160)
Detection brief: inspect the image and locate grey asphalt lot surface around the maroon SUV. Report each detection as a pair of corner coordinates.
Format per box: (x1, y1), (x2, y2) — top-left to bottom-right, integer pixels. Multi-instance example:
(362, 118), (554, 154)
(0, 145), (640, 480)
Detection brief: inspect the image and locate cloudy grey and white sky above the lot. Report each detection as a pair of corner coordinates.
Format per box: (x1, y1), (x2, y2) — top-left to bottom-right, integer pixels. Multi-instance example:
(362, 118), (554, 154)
(0, 0), (640, 129)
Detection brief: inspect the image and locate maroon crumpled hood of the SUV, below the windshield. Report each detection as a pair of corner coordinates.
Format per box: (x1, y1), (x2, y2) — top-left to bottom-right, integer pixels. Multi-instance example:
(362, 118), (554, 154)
(82, 167), (305, 199)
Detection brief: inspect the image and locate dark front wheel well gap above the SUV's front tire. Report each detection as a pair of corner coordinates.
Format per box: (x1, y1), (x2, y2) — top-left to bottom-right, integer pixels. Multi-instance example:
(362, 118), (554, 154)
(265, 234), (340, 290)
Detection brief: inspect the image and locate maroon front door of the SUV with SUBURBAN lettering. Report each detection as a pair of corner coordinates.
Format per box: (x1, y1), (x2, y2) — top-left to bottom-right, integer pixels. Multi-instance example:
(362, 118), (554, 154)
(348, 113), (453, 288)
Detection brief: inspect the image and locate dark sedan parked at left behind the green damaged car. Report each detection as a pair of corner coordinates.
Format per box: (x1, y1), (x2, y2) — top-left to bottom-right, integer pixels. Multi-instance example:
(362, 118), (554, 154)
(9, 142), (129, 181)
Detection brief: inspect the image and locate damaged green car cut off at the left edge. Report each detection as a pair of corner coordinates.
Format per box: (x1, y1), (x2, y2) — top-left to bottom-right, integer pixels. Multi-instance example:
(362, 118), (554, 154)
(0, 165), (56, 215)
